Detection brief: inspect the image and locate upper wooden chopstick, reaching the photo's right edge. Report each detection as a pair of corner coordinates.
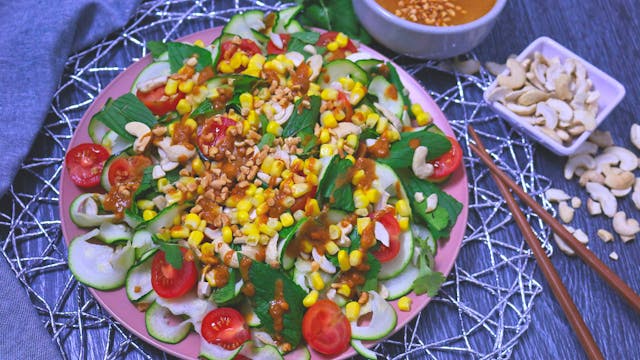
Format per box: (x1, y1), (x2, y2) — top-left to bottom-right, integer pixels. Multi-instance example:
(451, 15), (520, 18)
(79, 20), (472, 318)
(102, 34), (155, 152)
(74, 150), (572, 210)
(469, 125), (640, 313)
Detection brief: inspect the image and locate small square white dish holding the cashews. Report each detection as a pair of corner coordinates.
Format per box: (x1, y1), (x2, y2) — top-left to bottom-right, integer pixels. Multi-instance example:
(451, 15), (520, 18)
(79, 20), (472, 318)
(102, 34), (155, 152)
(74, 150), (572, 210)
(484, 36), (625, 156)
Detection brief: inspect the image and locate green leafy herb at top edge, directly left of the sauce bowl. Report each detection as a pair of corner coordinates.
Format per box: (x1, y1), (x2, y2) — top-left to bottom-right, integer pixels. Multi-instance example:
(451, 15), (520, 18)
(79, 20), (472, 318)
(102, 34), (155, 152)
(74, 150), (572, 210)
(296, 0), (371, 44)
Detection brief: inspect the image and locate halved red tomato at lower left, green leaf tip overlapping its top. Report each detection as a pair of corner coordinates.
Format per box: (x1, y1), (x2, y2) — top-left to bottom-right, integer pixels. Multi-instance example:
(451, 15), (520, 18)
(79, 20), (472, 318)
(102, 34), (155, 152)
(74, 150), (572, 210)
(151, 248), (198, 299)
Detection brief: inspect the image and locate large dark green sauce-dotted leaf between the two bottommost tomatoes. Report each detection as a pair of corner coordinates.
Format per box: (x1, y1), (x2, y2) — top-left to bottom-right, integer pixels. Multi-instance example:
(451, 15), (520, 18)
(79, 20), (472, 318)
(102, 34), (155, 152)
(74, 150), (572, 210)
(249, 261), (306, 348)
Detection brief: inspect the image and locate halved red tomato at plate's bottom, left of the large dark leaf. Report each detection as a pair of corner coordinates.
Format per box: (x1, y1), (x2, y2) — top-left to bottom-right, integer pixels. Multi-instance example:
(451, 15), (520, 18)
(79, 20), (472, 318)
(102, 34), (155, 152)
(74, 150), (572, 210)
(201, 308), (251, 350)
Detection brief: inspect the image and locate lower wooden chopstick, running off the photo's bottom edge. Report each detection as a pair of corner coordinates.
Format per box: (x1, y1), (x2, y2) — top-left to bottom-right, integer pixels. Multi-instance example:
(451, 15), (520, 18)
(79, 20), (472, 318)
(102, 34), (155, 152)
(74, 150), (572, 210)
(476, 140), (604, 359)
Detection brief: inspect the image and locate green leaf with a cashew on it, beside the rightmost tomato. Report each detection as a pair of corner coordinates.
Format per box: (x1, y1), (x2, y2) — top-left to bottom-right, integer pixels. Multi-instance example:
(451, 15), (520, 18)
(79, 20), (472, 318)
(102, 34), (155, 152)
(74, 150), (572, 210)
(377, 129), (451, 169)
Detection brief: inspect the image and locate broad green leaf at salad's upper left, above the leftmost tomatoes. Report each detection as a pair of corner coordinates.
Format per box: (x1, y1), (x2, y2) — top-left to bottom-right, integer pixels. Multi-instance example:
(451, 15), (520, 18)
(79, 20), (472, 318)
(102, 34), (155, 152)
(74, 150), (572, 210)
(94, 93), (156, 142)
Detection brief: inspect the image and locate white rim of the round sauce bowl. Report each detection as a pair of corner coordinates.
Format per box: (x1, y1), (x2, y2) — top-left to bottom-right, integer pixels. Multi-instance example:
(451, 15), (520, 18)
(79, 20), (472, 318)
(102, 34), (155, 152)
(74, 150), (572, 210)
(357, 0), (507, 34)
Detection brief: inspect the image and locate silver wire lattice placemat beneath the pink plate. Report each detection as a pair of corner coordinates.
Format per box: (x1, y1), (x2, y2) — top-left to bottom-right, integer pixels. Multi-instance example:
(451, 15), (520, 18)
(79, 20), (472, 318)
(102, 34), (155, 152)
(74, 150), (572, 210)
(0, 0), (551, 359)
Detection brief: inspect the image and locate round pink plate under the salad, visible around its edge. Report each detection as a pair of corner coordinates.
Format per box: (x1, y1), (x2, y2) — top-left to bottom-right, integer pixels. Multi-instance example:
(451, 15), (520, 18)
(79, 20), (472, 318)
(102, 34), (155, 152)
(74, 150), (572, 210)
(60, 27), (469, 359)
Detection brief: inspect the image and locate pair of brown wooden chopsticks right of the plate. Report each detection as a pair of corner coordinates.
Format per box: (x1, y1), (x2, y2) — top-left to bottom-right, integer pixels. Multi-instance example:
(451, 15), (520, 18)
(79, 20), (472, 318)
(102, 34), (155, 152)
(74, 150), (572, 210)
(469, 125), (640, 359)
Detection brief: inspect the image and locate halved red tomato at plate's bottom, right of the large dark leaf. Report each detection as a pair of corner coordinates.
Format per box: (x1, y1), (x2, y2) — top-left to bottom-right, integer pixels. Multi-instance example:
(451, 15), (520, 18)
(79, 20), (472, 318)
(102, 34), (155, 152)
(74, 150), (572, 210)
(302, 299), (351, 355)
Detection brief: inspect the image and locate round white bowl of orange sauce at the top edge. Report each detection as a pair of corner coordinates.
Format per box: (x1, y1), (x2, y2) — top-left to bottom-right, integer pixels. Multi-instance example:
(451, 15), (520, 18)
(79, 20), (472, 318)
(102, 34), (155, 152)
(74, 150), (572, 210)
(353, 0), (507, 59)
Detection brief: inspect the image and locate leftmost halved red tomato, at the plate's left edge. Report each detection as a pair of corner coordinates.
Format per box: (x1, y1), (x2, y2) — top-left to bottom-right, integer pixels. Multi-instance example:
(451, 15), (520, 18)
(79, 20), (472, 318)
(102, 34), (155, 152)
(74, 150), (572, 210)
(64, 143), (109, 188)
